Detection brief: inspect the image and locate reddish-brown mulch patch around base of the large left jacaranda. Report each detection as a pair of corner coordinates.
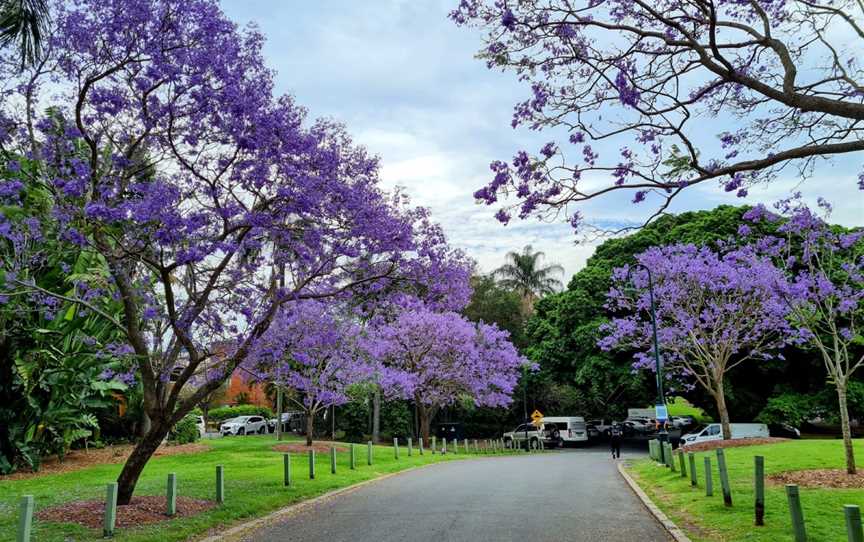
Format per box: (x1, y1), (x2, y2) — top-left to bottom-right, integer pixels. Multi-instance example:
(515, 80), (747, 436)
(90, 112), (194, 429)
(36, 495), (216, 529)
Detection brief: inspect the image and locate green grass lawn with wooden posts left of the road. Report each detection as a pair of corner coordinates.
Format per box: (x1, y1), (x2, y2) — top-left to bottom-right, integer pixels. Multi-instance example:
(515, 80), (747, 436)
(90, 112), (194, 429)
(0, 435), (512, 542)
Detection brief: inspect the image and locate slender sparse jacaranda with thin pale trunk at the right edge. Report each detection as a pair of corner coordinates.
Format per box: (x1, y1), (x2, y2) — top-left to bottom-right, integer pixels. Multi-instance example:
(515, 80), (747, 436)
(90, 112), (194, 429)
(741, 199), (864, 474)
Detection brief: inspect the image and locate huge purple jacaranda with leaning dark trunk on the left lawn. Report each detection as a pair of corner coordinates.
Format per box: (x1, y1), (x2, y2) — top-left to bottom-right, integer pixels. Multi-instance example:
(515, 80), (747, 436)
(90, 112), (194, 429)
(0, 0), (467, 504)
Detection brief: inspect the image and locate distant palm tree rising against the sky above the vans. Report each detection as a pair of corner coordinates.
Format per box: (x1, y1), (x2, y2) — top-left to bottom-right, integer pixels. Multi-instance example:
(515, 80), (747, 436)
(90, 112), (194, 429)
(492, 245), (564, 315)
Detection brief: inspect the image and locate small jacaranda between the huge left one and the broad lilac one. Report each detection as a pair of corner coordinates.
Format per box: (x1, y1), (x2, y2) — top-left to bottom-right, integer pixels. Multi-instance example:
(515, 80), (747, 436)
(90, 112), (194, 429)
(250, 301), (374, 446)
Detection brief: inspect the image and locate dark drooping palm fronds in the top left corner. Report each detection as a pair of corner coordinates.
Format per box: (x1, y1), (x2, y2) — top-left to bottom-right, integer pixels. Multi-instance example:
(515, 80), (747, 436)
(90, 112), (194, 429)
(0, 0), (49, 69)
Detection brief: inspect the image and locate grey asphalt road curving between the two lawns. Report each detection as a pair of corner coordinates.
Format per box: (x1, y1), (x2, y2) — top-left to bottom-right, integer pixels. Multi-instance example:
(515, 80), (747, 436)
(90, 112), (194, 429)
(244, 447), (670, 542)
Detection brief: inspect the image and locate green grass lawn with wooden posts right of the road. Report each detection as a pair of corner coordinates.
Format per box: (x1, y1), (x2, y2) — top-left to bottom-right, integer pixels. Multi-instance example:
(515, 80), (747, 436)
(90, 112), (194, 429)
(628, 439), (864, 542)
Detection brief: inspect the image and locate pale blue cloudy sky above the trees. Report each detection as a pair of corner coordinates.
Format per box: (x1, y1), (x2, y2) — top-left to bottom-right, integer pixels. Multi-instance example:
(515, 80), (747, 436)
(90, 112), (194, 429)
(222, 0), (864, 282)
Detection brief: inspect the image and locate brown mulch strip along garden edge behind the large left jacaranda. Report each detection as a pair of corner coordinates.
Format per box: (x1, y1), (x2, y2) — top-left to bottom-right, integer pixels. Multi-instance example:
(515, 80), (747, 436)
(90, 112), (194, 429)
(0, 442), (210, 481)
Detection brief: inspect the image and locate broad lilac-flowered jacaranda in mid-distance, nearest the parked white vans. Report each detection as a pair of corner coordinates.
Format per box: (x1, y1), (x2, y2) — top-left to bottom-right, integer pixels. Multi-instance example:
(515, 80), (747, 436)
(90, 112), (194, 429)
(364, 305), (526, 448)
